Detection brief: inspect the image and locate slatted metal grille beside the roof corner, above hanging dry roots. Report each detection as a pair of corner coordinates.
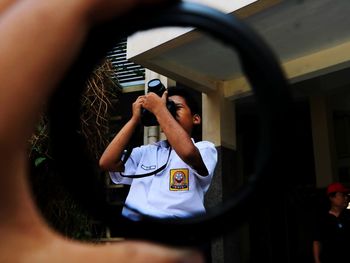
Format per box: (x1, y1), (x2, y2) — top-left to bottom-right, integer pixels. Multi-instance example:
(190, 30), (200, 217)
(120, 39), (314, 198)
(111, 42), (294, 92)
(107, 38), (145, 87)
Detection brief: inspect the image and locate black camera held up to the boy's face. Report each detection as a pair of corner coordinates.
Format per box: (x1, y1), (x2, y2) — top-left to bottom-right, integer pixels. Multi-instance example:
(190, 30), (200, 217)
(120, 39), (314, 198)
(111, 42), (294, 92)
(141, 79), (176, 126)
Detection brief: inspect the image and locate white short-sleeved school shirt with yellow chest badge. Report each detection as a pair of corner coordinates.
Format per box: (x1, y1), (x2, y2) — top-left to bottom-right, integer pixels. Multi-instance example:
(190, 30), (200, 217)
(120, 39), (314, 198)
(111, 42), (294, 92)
(110, 141), (217, 220)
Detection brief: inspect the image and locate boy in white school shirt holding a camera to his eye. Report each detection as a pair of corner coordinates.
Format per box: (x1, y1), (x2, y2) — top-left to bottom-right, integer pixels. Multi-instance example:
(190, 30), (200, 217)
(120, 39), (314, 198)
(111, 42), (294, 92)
(100, 81), (217, 220)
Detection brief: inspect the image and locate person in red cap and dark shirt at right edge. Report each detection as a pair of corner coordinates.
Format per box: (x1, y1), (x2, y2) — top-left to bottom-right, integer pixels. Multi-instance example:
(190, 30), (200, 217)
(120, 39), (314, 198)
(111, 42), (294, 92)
(313, 182), (350, 263)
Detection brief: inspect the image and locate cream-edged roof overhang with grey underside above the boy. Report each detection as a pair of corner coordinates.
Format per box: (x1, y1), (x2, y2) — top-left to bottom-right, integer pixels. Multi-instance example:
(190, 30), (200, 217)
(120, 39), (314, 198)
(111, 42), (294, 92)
(128, 0), (350, 99)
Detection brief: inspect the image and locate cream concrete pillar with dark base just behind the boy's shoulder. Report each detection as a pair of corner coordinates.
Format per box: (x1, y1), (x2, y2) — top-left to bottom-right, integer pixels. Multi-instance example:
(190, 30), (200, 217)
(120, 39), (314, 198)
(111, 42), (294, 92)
(202, 83), (240, 263)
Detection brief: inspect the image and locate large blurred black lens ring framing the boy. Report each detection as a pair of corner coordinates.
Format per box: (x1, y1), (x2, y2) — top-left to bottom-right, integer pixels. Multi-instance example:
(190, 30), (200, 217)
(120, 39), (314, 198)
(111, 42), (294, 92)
(49, 2), (291, 244)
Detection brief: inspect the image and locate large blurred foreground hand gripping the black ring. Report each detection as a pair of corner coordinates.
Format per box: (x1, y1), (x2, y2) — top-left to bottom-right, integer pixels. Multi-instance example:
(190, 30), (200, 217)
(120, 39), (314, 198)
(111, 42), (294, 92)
(0, 0), (202, 263)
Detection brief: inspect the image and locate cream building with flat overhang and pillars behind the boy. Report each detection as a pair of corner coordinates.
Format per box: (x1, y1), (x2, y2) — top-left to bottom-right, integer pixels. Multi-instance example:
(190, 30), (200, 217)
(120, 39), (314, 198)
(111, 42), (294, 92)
(107, 0), (350, 262)
